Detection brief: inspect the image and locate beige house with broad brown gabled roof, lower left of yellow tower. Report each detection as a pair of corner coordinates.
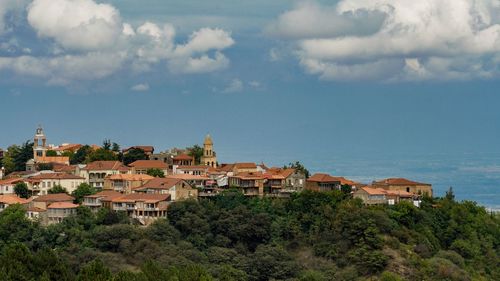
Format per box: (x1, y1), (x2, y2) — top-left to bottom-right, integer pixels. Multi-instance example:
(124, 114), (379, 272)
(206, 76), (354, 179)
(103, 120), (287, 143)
(134, 178), (198, 201)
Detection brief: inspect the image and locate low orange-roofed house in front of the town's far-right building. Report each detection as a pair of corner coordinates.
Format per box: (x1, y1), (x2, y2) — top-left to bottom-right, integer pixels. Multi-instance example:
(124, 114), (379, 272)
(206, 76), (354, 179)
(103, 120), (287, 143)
(353, 186), (420, 207)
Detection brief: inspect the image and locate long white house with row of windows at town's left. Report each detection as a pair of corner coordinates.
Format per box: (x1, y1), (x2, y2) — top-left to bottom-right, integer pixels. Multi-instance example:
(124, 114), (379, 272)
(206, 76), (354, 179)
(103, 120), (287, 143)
(26, 173), (85, 195)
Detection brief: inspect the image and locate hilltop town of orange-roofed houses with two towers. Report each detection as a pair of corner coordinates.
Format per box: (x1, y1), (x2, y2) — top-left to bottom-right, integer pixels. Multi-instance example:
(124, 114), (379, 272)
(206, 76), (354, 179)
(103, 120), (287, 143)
(0, 127), (433, 225)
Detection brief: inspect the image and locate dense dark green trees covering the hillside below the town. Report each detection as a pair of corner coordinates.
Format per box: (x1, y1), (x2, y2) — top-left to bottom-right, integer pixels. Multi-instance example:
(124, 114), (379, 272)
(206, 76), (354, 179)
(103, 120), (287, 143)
(0, 189), (500, 281)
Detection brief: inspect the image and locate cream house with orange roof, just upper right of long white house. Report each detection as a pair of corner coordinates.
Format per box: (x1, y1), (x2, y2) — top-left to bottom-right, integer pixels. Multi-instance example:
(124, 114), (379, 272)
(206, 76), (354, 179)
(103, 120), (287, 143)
(81, 161), (130, 189)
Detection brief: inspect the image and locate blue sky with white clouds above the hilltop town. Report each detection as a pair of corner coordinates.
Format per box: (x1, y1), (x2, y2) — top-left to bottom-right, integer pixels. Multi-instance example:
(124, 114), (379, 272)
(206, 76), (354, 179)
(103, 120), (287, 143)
(0, 0), (500, 196)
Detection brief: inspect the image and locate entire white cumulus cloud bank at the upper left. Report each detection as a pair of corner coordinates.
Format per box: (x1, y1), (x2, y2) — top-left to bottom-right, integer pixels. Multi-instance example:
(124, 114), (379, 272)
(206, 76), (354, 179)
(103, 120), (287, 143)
(0, 0), (234, 86)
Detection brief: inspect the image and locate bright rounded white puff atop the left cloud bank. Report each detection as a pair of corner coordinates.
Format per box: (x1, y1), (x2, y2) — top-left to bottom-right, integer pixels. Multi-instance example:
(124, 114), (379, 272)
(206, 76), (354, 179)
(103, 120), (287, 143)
(28, 0), (123, 50)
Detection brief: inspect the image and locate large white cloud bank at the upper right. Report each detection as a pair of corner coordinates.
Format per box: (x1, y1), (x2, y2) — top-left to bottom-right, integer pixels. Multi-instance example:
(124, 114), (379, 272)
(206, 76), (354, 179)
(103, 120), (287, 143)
(269, 0), (500, 81)
